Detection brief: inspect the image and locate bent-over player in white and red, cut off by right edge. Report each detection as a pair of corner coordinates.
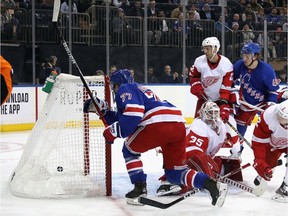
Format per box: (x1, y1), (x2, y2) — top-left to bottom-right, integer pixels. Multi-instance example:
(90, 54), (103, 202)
(252, 100), (288, 202)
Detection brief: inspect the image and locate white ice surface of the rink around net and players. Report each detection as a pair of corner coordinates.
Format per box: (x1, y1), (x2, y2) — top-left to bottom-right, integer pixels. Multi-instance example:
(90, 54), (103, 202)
(0, 125), (288, 216)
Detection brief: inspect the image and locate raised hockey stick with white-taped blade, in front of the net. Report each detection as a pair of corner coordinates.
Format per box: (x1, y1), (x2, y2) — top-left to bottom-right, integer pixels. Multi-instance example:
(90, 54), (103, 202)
(52, 0), (108, 127)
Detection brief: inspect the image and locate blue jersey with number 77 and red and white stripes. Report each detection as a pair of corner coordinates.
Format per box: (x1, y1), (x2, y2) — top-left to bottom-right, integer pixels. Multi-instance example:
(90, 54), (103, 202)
(105, 82), (186, 138)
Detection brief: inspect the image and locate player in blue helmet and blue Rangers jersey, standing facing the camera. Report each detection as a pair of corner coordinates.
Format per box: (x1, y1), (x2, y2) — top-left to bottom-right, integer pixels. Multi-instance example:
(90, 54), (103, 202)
(234, 43), (279, 147)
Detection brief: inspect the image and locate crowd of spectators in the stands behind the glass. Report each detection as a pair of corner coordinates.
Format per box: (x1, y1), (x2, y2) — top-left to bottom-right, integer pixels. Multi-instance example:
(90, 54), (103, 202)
(0, 0), (288, 83)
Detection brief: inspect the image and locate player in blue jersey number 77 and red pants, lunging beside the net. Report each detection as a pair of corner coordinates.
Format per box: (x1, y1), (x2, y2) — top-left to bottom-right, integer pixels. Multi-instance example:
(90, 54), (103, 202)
(84, 69), (227, 207)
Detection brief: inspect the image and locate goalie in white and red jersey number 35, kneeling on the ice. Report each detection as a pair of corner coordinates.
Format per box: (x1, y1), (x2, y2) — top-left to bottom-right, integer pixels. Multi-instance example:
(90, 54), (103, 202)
(157, 100), (243, 196)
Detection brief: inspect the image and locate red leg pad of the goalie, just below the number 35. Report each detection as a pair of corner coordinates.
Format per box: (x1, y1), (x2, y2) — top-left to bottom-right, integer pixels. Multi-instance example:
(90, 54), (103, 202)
(187, 154), (220, 178)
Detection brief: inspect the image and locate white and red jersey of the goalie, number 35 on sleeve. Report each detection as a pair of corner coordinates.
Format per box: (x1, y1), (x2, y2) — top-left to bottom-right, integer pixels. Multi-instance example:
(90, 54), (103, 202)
(186, 118), (226, 157)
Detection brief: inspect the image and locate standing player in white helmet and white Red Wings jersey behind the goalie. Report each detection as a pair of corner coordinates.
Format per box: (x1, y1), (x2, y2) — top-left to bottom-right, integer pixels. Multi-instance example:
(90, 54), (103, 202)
(190, 37), (240, 157)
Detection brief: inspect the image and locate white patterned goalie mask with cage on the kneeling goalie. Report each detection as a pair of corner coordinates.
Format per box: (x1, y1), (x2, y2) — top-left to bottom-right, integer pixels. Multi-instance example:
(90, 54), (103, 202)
(199, 101), (221, 130)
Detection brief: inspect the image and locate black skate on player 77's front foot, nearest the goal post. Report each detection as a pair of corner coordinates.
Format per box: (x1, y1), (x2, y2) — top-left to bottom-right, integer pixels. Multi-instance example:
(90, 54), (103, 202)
(125, 182), (147, 206)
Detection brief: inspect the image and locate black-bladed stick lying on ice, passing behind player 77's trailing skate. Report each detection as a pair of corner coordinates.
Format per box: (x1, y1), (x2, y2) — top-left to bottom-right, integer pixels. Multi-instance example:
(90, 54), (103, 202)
(138, 163), (250, 209)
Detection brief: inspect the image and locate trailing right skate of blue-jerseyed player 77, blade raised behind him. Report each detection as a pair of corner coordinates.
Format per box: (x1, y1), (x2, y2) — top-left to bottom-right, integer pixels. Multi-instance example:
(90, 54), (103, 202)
(204, 178), (228, 207)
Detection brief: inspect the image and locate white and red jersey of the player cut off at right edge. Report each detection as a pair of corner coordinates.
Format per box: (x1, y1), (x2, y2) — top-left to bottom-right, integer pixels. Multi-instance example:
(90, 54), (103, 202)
(252, 104), (288, 149)
